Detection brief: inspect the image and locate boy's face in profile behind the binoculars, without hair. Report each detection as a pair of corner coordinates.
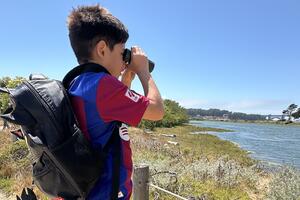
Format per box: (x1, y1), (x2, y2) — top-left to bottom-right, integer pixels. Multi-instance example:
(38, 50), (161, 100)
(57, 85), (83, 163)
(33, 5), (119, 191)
(106, 43), (125, 78)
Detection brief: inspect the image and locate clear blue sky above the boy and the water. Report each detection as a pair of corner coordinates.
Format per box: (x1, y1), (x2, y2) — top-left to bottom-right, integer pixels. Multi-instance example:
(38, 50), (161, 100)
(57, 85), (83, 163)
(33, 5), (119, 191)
(0, 0), (300, 114)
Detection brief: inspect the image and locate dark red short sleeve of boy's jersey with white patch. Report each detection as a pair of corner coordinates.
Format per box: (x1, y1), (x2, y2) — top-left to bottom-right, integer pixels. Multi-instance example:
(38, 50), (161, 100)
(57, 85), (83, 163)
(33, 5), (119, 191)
(96, 75), (149, 126)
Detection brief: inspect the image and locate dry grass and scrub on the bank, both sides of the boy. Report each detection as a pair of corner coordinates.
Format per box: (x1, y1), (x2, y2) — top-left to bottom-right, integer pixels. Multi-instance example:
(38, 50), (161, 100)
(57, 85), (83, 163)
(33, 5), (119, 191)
(0, 126), (300, 200)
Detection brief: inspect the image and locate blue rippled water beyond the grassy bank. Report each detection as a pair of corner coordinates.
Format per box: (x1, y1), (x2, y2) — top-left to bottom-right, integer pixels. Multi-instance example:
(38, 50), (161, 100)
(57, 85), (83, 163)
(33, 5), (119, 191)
(190, 121), (300, 168)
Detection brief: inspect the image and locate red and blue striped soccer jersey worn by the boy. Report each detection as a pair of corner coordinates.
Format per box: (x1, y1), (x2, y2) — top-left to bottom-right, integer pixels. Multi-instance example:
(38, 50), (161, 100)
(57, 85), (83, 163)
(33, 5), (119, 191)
(69, 69), (149, 200)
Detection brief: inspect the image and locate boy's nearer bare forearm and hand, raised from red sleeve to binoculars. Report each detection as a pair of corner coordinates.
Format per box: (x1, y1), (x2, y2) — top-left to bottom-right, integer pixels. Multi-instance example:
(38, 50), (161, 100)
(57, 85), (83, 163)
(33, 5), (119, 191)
(128, 47), (164, 120)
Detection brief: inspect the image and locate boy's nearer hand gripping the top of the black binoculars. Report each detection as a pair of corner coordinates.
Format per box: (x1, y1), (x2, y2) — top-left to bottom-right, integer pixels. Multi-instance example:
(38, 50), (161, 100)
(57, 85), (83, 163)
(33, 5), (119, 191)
(128, 46), (149, 75)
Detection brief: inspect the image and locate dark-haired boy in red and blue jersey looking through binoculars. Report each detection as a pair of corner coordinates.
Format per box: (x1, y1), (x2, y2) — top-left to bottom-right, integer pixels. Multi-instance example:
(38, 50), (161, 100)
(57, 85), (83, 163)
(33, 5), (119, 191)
(68, 5), (164, 200)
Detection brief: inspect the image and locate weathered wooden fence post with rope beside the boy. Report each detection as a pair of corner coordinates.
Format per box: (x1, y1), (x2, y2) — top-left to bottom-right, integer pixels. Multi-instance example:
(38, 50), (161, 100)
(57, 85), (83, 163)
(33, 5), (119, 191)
(133, 165), (149, 200)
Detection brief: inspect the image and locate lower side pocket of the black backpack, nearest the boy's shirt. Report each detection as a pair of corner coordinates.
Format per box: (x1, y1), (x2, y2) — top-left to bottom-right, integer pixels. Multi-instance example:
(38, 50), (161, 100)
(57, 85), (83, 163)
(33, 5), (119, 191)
(50, 129), (105, 194)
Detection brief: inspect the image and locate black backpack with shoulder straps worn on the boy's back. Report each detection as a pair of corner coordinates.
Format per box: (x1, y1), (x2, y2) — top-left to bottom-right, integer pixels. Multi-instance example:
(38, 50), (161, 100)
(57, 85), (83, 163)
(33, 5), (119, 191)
(0, 63), (120, 200)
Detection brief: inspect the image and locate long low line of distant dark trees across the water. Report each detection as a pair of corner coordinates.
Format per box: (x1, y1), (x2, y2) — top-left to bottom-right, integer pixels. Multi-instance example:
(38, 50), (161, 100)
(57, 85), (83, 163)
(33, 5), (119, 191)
(187, 108), (265, 120)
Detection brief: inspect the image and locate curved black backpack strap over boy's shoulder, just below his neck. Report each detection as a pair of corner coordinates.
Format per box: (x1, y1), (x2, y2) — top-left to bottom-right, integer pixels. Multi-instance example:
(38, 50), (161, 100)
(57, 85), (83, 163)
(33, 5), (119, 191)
(62, 63), (110, 89)
